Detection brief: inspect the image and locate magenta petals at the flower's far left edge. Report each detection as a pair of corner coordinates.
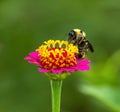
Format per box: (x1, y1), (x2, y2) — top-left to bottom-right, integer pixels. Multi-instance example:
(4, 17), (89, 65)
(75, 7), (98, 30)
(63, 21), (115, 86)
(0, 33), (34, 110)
(24, 52), (40, 65)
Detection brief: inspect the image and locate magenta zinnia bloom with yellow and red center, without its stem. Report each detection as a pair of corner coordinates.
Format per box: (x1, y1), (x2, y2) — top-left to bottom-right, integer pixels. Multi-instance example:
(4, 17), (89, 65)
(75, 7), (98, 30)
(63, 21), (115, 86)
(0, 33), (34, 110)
(25, 40), (90, 78)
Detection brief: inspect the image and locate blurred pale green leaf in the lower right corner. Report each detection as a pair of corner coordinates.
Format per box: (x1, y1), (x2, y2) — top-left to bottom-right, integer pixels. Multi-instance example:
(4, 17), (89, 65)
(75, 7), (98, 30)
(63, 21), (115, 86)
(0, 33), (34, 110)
(79, 85), (120, 112)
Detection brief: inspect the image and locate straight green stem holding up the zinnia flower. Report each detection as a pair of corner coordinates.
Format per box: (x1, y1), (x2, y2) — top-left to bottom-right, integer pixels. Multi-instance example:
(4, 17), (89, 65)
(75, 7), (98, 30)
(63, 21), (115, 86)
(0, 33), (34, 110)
(50, 80), (62, 112)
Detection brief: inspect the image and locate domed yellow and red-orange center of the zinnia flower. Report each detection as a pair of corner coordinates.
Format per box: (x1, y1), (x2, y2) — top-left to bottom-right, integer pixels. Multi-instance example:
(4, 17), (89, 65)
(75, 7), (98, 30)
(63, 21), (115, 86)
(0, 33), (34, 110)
(36, 40), (78, 70)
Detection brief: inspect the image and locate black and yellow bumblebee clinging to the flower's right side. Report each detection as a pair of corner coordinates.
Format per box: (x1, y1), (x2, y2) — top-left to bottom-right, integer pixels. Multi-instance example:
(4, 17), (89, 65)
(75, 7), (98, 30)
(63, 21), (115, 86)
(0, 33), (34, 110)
(68, 29), (94, 58)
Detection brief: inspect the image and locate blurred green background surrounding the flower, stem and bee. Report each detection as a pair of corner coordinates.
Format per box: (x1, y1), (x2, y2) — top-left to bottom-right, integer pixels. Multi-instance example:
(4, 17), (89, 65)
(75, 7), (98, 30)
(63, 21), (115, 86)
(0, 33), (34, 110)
(0, 0), (120, 112)
